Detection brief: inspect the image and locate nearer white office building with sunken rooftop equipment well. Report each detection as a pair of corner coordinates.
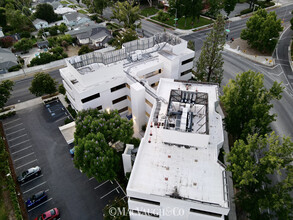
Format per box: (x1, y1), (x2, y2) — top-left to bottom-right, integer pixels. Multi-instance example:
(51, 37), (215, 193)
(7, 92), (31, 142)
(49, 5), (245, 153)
(127, 79), (229, 220)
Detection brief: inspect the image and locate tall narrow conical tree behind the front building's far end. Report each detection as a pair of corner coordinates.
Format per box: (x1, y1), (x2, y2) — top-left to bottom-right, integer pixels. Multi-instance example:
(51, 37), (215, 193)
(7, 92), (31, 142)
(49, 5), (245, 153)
(194, 15), (225, 84)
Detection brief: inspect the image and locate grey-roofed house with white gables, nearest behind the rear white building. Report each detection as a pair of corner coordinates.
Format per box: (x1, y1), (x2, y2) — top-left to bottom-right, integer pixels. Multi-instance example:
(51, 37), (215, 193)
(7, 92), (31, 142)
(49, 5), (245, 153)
(66, 24), (112, 47)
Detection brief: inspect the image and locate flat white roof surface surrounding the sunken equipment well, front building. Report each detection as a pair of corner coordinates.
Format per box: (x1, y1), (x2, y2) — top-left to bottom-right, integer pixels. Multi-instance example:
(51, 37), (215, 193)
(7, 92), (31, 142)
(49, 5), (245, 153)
(127, 79), (228, 207)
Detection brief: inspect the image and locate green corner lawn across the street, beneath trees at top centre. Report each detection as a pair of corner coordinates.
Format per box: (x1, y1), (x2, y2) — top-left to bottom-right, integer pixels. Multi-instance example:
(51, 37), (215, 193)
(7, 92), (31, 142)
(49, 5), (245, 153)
(152, 16), (213, 30)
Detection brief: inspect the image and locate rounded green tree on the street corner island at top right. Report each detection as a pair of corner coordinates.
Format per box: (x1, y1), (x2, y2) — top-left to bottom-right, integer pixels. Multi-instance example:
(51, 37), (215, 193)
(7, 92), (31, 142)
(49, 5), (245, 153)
(240, 9), (283, 52)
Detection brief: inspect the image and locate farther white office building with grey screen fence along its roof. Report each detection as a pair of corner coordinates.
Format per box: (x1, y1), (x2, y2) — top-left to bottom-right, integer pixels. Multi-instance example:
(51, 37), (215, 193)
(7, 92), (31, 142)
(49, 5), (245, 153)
(60, 33), (194, 132)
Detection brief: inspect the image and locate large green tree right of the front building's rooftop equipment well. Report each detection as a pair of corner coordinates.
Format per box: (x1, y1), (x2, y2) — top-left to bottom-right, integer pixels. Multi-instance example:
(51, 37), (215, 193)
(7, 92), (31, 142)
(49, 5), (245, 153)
(220, 70), (283, 140)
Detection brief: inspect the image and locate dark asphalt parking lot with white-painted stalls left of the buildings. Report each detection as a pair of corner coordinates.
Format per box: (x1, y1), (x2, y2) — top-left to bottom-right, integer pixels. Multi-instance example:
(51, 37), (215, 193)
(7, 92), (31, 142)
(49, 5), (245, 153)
(3, 102), (125, 220)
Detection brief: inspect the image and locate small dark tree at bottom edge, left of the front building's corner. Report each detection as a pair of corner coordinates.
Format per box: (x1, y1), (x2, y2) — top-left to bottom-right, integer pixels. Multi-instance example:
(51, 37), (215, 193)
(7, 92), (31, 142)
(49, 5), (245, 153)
(103, 198), (129, 220)
